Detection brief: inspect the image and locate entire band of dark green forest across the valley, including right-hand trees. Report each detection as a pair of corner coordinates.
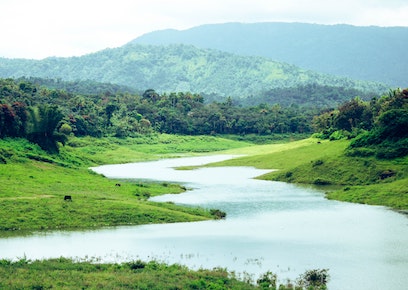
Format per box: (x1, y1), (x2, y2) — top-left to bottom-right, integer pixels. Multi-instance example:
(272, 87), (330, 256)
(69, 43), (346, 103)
(0, 79), (408, 158)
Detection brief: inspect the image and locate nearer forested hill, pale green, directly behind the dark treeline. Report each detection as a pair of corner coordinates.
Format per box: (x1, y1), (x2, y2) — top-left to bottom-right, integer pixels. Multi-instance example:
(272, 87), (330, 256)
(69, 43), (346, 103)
(0, 44), (388, 105)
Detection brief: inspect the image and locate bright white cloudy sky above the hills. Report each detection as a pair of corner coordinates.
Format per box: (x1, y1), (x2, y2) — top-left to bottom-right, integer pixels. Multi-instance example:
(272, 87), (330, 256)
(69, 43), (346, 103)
(0, 0), (408, 59)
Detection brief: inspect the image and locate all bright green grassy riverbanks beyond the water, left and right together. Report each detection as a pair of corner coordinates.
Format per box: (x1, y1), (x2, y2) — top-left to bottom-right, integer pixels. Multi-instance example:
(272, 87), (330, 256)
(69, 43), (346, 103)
(0, 134), (408, 236)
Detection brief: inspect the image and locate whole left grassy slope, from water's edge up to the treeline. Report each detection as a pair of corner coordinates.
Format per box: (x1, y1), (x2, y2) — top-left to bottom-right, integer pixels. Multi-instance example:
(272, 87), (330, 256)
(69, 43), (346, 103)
(0, 135), (250, 236)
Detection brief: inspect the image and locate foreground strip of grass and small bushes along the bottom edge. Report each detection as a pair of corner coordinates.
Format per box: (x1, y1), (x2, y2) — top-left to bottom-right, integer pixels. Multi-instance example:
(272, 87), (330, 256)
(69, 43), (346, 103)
(0, 258), (329, 290)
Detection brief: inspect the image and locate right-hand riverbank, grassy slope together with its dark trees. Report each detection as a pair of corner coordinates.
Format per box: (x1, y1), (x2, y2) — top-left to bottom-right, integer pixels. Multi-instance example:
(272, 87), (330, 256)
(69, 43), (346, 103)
(209, 90), (408, 211)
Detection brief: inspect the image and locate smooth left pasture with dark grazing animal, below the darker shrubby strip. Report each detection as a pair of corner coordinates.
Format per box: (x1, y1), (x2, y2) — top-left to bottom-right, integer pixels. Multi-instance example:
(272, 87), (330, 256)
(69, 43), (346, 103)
(0, 161), (210, 232)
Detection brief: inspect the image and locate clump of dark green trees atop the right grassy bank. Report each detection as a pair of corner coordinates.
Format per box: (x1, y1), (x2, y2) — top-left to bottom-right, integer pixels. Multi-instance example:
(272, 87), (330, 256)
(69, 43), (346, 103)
(313, 89), (408, 159)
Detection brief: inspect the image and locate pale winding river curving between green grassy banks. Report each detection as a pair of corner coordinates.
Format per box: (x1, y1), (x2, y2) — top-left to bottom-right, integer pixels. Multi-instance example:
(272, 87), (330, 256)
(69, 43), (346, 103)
(0, 155), (408, 289)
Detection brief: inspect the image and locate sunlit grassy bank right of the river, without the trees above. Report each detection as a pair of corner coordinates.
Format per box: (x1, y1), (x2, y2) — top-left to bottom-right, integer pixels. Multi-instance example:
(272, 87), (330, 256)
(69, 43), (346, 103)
(213, 138), (408, 211)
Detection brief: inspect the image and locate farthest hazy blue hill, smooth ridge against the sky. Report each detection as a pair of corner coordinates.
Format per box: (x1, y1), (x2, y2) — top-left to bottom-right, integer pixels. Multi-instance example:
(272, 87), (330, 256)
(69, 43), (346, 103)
(132, 23), (408, 87)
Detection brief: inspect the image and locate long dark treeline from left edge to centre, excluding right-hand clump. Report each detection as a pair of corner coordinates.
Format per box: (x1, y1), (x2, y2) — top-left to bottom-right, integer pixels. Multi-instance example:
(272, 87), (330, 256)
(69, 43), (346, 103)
(0, 79), (315, 147)
